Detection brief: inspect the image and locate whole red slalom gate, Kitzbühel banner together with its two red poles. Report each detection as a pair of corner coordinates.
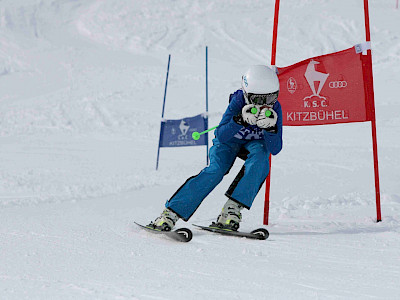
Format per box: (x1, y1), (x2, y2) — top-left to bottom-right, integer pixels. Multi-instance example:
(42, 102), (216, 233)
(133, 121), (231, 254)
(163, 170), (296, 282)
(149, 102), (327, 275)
(263, 0), (382, 225)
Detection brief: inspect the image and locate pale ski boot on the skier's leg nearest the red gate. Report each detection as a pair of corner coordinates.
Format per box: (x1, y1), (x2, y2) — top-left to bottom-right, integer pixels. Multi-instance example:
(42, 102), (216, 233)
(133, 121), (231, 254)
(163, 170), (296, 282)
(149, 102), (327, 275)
(210, 199), (243, 231)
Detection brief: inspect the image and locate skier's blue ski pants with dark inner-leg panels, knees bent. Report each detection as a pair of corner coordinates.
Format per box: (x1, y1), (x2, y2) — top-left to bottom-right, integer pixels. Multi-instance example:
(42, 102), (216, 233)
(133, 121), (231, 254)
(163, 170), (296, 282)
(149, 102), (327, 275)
(165, 138), (269, 221)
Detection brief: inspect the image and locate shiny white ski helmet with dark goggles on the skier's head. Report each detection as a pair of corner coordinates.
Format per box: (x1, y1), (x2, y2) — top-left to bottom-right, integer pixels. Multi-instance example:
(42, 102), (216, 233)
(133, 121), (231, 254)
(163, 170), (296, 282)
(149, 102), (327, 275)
(242, 65), (279, 105)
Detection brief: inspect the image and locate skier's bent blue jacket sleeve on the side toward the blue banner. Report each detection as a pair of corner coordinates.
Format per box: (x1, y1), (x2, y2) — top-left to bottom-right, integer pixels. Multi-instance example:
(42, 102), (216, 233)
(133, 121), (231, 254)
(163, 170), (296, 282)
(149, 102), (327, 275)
(215, 94), (243, 143)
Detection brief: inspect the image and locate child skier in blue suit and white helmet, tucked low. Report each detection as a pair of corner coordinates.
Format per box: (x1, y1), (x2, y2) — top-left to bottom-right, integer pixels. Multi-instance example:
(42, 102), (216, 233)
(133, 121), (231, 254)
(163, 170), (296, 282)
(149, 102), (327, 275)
(149, 65), (282, 231)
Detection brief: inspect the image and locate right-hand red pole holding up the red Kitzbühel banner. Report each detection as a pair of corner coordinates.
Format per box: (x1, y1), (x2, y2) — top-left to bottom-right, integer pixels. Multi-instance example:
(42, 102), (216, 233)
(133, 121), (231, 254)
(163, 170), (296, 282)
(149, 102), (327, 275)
(364, 0), (382, 222)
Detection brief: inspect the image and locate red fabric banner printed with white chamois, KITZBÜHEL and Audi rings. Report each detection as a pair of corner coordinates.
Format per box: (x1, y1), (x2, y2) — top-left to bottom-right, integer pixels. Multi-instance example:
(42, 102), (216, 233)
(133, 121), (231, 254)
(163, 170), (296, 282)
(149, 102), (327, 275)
(278, 44), (370, 126)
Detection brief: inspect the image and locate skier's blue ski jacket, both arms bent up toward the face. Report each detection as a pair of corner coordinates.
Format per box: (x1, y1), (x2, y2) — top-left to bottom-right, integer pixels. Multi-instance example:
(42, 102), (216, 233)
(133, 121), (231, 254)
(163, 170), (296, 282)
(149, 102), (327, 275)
(215, 89), (282, 155)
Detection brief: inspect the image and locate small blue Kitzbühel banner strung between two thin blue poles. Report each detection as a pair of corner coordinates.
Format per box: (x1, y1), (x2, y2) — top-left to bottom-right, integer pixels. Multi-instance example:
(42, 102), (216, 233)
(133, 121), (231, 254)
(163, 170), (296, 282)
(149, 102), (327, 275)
(159, 114), (208, 147)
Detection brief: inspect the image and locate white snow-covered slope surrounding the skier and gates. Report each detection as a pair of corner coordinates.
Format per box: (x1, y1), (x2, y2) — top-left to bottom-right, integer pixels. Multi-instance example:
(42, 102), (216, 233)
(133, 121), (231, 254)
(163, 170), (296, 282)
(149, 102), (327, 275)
(0, 0), (400, 300)
